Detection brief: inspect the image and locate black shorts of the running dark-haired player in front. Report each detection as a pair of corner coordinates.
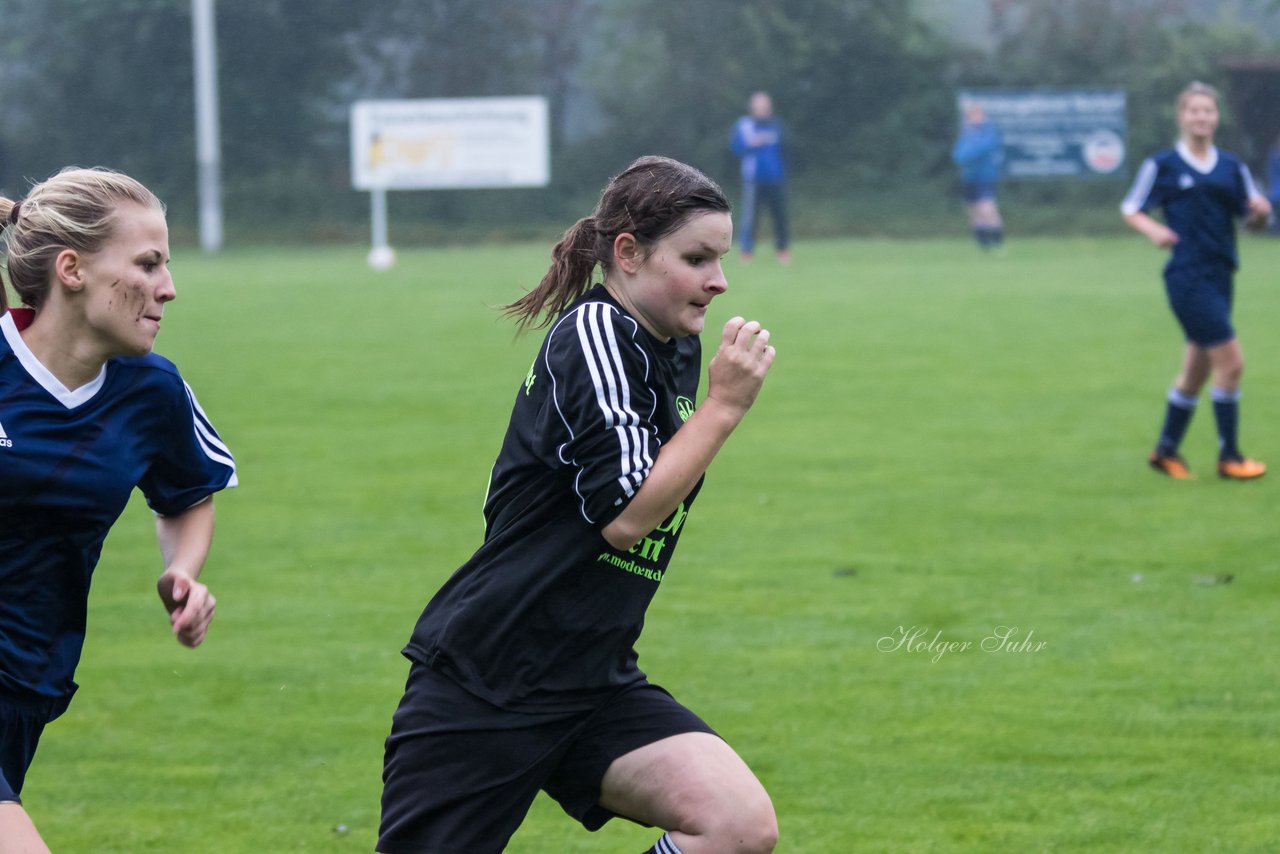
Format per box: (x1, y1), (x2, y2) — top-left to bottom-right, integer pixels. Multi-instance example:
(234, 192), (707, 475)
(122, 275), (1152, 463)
(378, 662), (714, 854)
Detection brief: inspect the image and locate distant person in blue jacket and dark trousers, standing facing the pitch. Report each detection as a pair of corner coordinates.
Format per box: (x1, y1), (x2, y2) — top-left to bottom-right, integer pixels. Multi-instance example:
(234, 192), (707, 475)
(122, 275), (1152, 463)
(731, 92), (791, 264)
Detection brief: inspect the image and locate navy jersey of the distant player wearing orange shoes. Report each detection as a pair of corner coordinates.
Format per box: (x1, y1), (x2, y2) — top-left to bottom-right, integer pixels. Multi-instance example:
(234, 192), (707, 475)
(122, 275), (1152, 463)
(1120, 142), (1260, 270)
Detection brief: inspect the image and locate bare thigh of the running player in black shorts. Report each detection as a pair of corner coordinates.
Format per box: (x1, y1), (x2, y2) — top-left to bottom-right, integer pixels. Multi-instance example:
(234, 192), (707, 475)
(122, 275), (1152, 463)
(600, 732), (773, 834)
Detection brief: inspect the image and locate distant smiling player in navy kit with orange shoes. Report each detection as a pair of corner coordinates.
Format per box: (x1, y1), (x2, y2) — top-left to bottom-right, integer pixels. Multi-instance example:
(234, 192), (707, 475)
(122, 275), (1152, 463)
(1120, 83), (1271, 480)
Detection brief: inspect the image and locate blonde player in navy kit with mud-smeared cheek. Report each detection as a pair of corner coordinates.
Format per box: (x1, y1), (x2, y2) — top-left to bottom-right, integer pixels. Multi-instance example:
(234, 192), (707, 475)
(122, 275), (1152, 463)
(0, 169), (236, 853)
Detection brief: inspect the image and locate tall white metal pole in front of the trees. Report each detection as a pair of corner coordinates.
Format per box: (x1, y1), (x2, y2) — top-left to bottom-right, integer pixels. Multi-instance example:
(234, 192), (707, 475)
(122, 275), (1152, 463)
(191, 0), (223, 252)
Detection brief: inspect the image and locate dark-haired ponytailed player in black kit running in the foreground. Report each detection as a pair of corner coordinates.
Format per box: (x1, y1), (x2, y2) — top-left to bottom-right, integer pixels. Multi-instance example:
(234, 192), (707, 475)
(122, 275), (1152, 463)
(378, 157), (777, 854)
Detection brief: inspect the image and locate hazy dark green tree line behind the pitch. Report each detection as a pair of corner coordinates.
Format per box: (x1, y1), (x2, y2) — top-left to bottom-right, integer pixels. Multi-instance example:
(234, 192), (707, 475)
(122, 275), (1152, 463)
(0, 0), (1277, 238)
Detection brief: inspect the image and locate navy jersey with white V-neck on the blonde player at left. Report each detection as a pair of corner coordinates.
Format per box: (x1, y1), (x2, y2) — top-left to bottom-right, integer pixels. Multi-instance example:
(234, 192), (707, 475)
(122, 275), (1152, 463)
(0, 310), (236, 699)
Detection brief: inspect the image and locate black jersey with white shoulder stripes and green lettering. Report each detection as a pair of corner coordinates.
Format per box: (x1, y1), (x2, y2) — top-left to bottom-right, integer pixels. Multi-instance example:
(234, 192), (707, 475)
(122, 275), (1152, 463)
(404, 286), (701, 711)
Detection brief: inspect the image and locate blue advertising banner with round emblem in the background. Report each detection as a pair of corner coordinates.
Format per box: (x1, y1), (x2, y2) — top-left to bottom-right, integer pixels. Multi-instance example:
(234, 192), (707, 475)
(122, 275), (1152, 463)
(957, 90), (1125, 179)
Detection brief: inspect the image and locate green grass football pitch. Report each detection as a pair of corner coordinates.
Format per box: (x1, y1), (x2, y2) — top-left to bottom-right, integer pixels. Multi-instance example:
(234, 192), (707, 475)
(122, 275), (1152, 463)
(24, 236), (1280, 854)
